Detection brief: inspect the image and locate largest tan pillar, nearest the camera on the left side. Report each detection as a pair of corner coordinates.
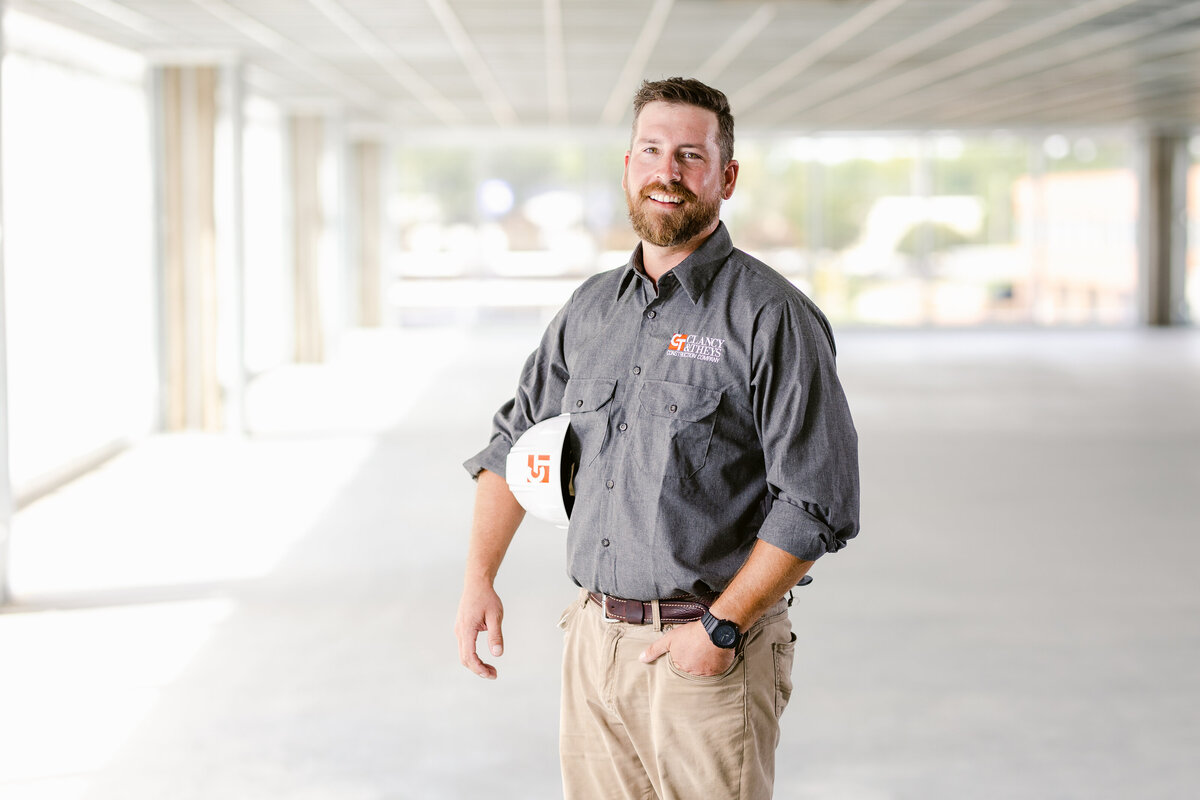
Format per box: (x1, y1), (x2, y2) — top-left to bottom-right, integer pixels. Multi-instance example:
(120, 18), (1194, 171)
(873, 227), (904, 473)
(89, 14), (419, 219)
(160, 66), (222, 431)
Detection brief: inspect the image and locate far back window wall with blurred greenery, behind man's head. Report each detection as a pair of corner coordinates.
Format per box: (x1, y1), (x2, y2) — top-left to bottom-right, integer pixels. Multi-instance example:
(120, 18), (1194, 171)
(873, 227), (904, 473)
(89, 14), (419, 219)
(394, 132), (1138, 325)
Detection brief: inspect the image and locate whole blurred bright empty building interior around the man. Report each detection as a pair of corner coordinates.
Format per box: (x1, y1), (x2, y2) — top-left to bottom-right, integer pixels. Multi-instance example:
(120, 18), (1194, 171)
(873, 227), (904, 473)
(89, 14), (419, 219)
(0, 0), (1200, 799)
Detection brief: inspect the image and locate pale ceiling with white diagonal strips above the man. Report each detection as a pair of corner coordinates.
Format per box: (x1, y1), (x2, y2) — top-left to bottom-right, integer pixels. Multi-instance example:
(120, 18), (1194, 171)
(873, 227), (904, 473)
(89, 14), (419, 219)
(14, 0), (1200, 131)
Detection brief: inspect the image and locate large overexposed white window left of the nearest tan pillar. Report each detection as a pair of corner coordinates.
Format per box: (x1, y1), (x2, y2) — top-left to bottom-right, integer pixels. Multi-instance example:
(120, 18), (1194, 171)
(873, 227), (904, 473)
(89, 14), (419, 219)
(4, 54), (157, 493)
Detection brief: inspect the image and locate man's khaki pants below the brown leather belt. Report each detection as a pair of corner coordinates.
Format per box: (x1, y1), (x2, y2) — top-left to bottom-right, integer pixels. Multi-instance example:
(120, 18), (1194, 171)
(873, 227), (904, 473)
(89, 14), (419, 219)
(559, 593), (796, 800)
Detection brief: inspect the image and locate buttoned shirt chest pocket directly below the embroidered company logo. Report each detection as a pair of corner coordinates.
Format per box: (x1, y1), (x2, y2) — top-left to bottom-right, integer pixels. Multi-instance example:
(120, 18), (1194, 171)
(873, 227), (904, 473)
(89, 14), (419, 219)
(634, 380), (721, 477)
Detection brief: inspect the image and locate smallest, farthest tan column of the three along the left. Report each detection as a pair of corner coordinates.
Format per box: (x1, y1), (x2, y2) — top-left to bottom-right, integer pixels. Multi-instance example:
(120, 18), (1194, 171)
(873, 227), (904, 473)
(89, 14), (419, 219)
(352, 142), (383, 327)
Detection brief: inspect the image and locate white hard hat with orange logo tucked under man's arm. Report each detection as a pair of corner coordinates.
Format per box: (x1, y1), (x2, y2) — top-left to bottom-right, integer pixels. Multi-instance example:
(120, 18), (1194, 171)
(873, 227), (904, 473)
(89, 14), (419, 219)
(504, 414), (576, 528)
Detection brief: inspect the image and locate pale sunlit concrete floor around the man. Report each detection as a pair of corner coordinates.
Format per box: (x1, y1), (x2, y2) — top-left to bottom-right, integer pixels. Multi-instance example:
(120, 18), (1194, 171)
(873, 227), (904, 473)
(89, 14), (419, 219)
(0, 327), (1200, 800)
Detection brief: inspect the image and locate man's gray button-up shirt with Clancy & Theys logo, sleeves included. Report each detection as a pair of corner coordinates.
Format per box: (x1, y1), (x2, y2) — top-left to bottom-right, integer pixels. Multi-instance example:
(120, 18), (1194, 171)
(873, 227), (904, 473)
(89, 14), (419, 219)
(464, 223), (858, 600)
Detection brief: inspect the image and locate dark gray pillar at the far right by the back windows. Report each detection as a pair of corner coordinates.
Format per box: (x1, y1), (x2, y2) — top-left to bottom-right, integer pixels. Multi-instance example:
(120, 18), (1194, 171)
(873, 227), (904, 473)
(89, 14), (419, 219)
(1138, 131), (1189, 325)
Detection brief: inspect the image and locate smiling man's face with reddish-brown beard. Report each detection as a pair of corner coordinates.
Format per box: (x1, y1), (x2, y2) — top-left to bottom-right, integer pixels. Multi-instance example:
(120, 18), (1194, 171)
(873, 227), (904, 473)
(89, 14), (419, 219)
(620, 102), (738, 247)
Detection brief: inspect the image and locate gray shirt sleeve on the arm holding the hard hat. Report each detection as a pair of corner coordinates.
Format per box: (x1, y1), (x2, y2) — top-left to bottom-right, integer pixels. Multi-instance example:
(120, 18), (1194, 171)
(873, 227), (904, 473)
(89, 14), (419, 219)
(463, 295), (574, 479)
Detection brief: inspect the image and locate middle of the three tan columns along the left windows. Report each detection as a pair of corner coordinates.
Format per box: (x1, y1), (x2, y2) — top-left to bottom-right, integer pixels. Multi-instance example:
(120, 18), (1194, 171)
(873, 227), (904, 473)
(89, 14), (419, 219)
(289, 116), (325, 363)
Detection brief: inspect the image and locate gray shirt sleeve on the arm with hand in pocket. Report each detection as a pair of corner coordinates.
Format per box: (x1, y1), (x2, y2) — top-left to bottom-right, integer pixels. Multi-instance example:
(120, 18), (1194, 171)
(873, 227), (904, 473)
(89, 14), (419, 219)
(751, 301), (859, 560)
